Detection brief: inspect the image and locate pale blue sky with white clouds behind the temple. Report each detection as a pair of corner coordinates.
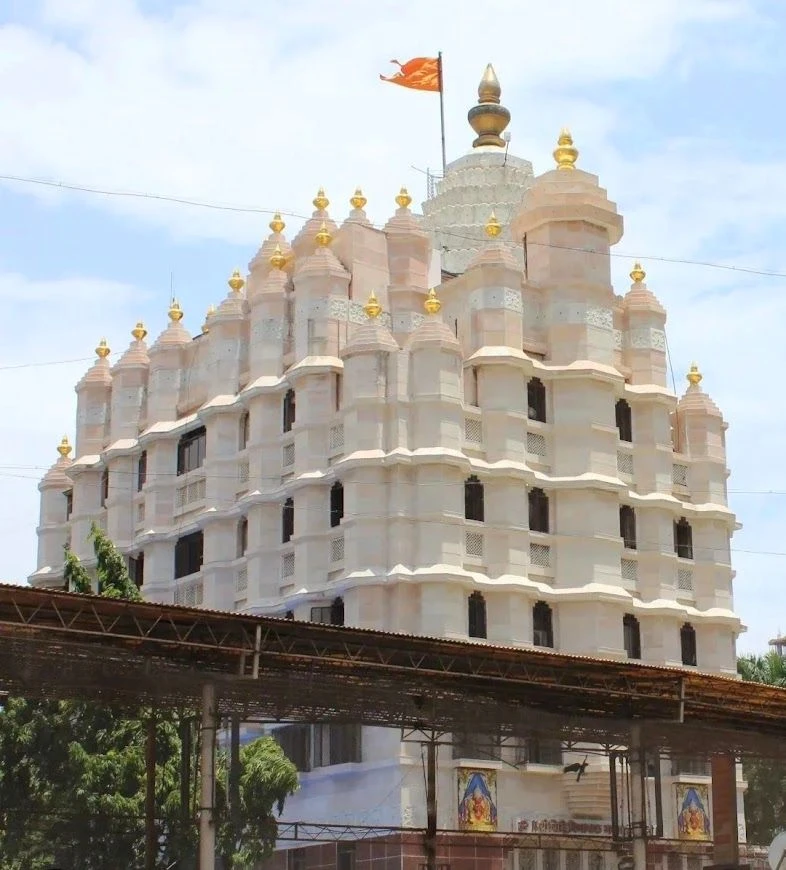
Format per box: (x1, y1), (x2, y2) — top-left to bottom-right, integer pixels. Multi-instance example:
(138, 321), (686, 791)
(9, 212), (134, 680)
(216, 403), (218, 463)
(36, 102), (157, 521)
(0, 0), (786, 650)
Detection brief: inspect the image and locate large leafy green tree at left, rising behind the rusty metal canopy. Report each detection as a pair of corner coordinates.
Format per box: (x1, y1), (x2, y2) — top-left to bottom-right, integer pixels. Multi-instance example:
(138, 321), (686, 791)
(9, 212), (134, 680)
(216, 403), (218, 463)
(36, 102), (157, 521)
(0, 526), (297, 870)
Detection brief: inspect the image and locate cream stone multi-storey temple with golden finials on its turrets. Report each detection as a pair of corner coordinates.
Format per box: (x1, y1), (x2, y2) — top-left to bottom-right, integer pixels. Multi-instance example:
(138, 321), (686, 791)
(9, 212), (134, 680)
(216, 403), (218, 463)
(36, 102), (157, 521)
(30, 68), (744, 870)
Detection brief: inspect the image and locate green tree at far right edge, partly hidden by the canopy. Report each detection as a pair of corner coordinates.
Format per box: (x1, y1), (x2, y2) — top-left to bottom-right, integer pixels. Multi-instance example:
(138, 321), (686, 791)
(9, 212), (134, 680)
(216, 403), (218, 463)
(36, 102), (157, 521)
(737, 650), (786, 846)
